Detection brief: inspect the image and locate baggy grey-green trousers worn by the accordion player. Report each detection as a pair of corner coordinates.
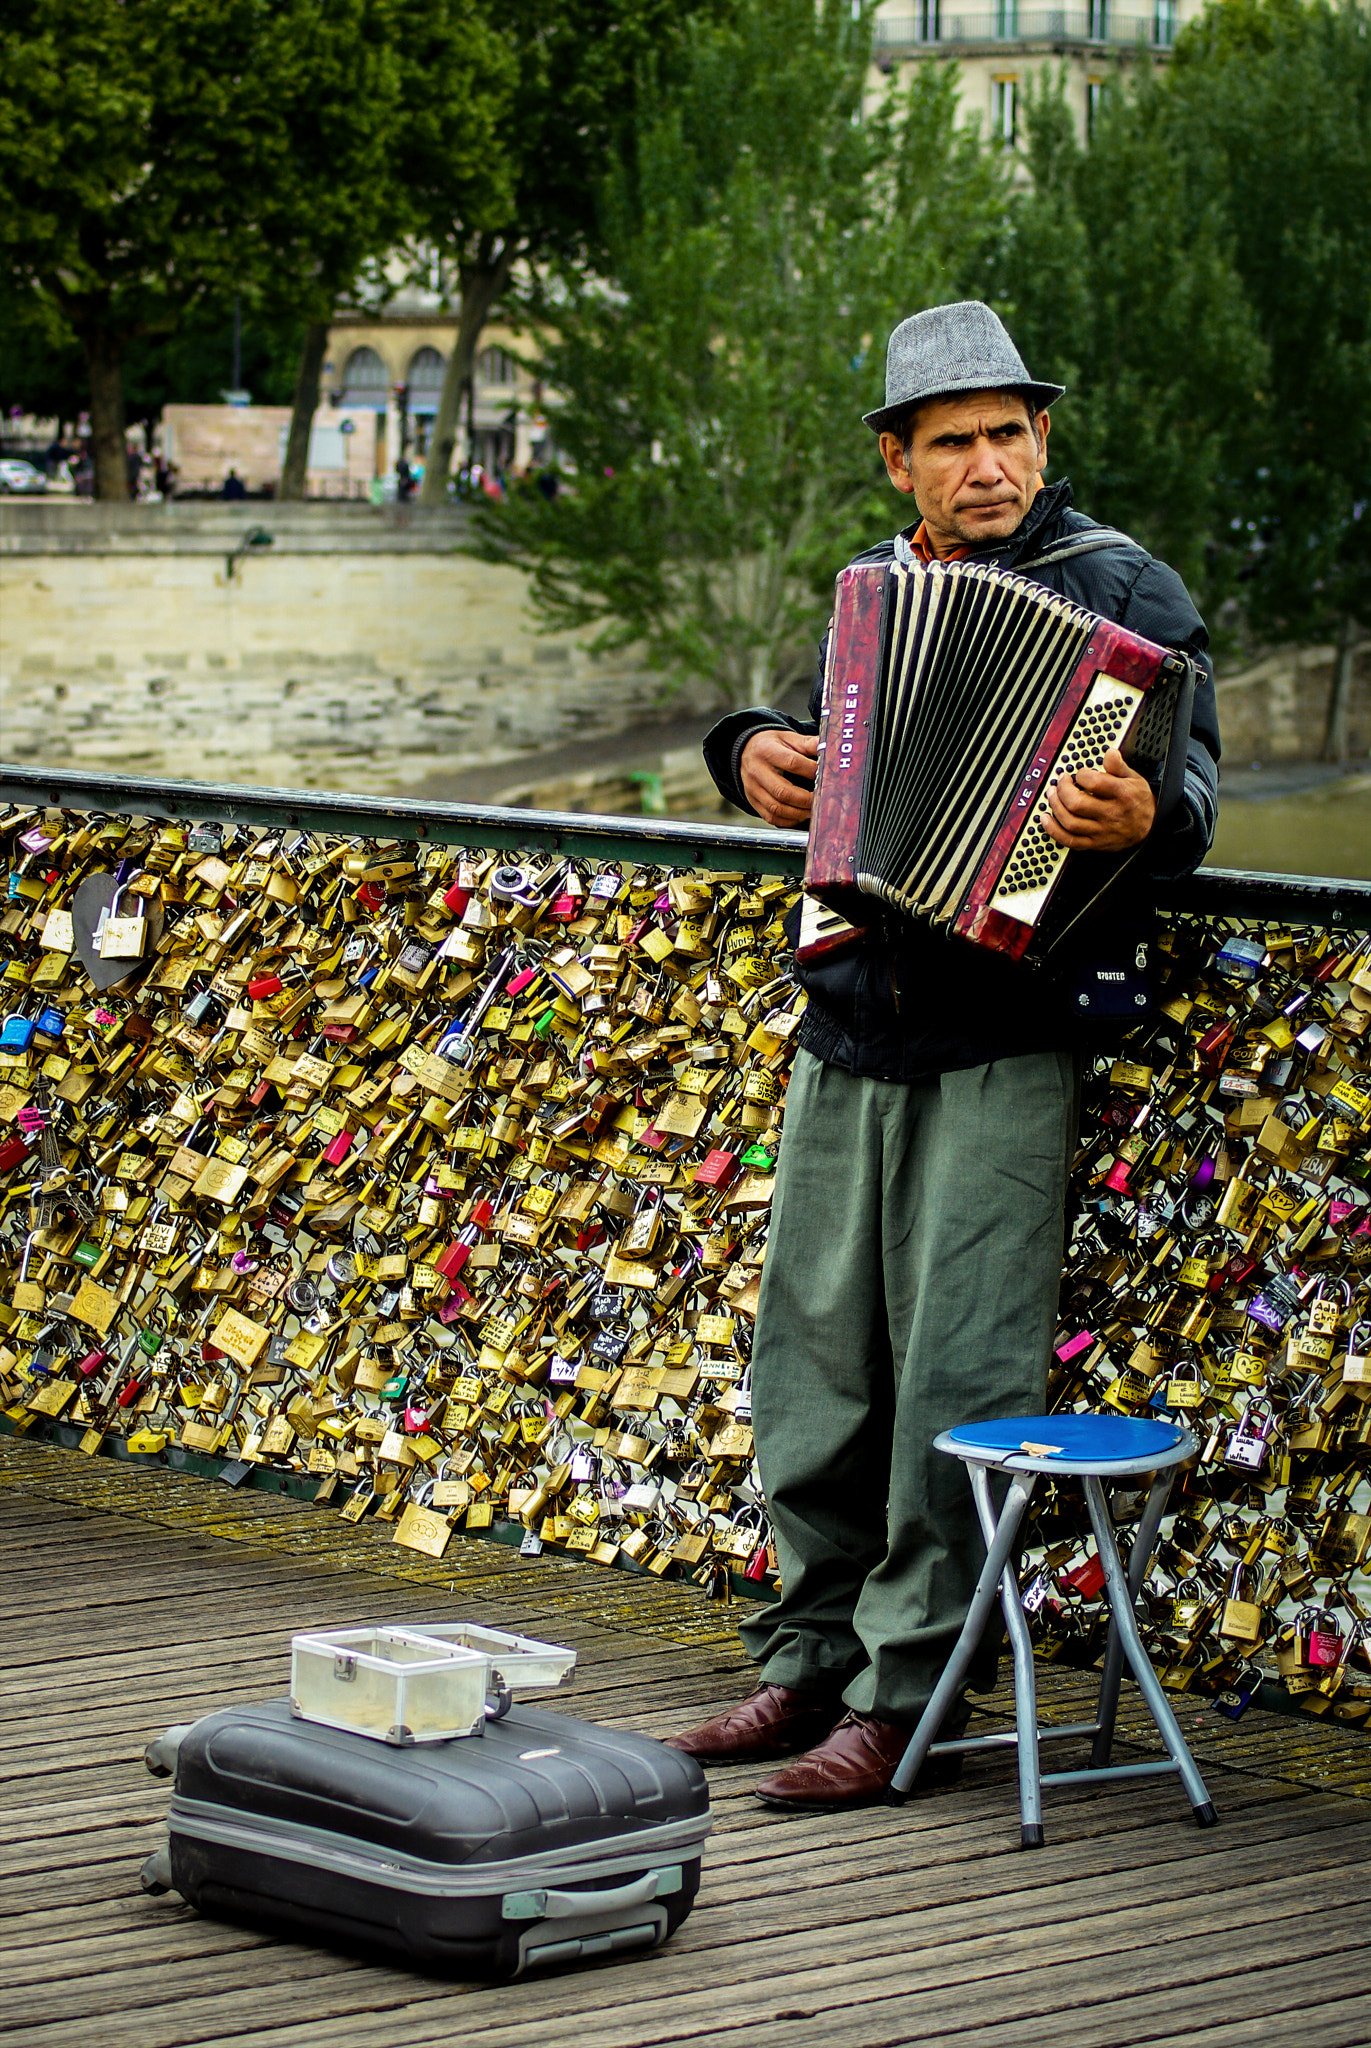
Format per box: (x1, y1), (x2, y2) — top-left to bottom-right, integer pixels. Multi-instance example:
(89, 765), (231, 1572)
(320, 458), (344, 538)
(742, 1053), (1078, 1726)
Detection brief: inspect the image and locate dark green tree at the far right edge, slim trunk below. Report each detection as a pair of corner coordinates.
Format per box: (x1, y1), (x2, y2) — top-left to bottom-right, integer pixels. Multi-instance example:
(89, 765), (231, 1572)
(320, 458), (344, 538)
(1170, 0), (1371, 760)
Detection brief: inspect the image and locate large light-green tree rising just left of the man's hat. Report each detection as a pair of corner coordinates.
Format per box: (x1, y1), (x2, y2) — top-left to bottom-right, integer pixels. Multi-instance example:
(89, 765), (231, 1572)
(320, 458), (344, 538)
(477, 0), (1004, 702)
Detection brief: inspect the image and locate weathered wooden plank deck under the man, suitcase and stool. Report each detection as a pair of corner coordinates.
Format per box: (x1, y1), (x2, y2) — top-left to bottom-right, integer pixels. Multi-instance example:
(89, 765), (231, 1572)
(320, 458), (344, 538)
(0, 1442), (1371, 2048)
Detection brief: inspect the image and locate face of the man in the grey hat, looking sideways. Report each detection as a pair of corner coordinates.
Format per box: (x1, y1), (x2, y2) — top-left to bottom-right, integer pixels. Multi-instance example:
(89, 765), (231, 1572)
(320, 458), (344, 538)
(881, 391), (1049, 551)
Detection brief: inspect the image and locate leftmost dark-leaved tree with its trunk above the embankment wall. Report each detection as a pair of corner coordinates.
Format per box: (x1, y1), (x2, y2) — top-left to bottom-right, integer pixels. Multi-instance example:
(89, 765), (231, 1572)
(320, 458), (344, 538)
(0, 0), (496, 498)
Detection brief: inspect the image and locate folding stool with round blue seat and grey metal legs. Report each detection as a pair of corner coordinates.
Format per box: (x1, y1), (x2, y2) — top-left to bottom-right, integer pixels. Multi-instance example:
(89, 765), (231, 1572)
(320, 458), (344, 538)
(891, 1415), (1217, 1849)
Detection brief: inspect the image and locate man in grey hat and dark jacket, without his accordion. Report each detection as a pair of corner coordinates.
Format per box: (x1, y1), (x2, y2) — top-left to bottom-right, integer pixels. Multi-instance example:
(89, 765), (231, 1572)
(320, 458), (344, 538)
(672, 301), (1219, 1810)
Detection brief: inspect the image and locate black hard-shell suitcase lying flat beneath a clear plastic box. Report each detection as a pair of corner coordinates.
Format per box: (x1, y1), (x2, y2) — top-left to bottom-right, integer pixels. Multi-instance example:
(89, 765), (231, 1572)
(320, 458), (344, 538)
(143, 1700), (709, 1978)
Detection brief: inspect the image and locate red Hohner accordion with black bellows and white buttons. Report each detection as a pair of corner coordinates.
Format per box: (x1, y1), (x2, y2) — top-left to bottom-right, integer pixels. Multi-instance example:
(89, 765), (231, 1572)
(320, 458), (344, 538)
(797, 561), (1195, 965)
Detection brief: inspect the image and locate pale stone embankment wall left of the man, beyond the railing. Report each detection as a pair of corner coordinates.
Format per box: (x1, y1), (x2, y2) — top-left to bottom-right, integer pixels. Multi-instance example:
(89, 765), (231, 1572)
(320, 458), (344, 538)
(0, 502), (703, 793)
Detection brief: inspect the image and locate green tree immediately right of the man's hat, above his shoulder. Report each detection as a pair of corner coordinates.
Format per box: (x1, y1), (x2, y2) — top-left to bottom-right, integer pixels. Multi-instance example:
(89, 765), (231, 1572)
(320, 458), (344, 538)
(998, 70), (1266, 608)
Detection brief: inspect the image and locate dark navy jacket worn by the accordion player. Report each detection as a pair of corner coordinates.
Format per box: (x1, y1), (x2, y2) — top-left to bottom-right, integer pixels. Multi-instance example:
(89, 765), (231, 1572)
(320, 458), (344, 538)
(705, 481), (1219, 1081)
